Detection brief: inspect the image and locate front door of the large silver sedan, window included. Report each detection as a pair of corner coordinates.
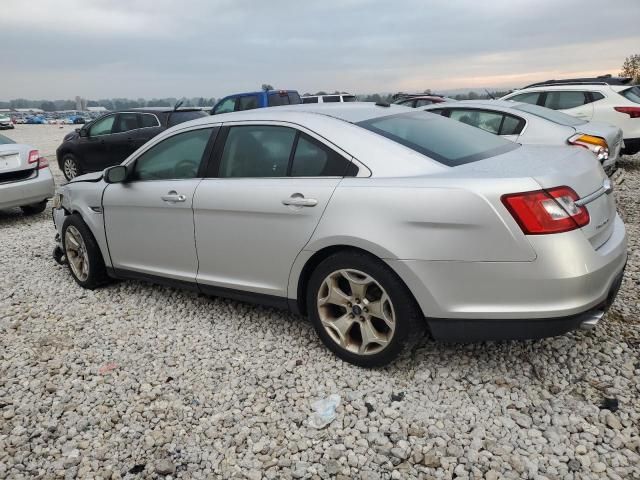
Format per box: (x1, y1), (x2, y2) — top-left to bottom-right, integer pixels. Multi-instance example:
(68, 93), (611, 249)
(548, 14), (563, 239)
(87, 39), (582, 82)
(103, 127), (214, 282)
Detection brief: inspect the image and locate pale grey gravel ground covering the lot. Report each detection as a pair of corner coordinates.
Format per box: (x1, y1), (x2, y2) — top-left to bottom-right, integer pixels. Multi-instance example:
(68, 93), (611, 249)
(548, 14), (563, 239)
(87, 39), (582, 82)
(0, 126), (640, 479)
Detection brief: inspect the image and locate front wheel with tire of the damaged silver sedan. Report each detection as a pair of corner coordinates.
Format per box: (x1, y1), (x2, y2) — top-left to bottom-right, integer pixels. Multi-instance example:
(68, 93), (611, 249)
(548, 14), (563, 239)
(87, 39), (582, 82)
(62, 213), (109, 290)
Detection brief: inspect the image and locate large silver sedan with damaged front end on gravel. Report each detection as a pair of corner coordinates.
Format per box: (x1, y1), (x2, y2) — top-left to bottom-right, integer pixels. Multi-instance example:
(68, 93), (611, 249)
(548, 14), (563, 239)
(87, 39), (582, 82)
(53, 103), (627, 367)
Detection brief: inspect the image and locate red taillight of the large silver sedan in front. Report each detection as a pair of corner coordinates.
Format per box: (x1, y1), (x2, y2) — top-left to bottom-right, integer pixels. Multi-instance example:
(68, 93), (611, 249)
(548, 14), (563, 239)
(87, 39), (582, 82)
(501, 187), (589, 235)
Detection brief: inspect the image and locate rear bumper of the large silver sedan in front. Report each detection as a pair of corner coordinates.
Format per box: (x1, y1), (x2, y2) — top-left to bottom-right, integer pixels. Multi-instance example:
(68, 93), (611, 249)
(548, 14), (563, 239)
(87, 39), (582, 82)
(388, 215), (627, 339)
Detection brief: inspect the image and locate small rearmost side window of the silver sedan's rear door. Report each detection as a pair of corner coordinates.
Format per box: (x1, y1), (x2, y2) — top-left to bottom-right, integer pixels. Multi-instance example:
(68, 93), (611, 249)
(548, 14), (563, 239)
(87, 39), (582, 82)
(291, 134), (358, 177)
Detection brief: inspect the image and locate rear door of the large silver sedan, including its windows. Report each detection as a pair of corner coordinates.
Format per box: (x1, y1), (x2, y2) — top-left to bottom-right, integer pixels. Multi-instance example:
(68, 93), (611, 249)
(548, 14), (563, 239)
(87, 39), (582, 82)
(193, 122), (355, 297)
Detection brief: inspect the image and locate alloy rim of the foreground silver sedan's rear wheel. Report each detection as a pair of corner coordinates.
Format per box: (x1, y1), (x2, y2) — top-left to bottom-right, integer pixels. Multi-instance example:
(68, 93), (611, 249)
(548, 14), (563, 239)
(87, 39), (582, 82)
(317, 269), (396, 355)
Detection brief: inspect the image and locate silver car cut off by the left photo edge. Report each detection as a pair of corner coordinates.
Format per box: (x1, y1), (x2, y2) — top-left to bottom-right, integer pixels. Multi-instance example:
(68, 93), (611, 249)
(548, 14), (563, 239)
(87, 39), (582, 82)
(0, 135), (55, 215)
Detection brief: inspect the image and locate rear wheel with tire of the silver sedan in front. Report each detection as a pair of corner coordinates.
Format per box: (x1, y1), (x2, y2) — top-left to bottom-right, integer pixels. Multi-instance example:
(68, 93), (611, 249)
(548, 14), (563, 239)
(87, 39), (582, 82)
(307, 251), (426, 367)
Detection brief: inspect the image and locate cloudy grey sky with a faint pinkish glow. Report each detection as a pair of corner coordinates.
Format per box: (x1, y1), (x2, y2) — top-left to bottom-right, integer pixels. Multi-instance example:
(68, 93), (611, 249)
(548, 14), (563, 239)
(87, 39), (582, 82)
(0, 0), (640, 100)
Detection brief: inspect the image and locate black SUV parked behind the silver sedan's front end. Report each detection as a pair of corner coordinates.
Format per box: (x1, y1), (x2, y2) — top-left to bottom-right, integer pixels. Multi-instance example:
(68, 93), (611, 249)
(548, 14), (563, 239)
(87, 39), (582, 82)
(56, 107), (208, 180)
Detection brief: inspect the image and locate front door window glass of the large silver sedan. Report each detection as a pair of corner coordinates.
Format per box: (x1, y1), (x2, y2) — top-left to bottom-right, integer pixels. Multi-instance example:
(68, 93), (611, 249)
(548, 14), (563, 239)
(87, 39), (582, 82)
(133, 128), (212, 180)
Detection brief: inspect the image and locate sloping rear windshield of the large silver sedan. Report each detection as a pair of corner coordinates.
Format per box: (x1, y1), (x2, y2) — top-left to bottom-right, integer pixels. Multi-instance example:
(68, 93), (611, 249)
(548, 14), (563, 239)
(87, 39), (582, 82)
(356, 112), (519, 167)
